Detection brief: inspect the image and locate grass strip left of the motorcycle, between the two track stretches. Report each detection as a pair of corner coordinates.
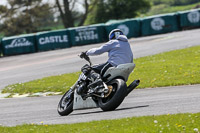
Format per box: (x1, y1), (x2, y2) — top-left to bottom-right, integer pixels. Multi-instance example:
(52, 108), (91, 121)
(2, 72), (80, 94)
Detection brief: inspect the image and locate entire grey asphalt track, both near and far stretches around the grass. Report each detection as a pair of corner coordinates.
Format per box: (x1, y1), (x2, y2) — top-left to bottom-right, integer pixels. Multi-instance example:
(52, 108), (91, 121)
(0, 29), (200, 126)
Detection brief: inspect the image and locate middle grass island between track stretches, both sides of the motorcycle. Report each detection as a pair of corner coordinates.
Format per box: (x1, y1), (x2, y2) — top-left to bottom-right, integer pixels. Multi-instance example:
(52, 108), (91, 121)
(3, 46), (200, 94)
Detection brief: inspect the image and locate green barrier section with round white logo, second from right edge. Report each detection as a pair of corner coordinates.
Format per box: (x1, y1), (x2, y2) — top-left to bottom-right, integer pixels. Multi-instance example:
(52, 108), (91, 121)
(141, 13), (180, 36)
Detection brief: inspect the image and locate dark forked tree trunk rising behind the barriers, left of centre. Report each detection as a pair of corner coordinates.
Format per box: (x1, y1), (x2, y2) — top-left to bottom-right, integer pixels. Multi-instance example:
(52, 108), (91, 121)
(55, 0), (98, 28)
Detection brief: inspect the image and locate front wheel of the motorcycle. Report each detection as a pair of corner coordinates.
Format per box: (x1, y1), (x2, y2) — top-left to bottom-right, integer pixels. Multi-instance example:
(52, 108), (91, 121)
(57, 90), (74, 116)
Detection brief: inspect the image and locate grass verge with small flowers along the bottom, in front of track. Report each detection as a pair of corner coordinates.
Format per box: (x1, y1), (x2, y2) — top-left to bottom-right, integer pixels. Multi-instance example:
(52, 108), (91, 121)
(0, 113), (200, 133)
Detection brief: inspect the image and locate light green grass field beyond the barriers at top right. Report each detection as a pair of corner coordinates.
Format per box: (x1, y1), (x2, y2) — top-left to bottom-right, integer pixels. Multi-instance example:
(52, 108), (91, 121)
(141, 2), (200, 17)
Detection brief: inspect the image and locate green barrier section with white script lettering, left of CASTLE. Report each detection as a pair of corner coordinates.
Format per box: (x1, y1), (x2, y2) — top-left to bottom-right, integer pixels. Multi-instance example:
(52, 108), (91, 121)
(2, 34), (36, 55)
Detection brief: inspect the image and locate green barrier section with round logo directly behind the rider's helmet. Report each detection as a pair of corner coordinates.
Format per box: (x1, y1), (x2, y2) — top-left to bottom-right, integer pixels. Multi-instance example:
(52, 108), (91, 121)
(106, 19), (141, 38)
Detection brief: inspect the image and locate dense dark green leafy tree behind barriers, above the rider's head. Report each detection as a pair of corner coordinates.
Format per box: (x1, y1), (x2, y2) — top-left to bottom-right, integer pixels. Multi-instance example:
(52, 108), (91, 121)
(86, 0), (150, 24)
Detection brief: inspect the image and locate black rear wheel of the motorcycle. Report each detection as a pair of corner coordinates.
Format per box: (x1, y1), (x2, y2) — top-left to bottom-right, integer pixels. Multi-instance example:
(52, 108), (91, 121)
(98, 79), (127, 111)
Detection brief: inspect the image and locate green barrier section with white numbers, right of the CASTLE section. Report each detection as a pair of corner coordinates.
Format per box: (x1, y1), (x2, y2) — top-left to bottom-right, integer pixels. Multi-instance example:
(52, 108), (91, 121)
(68, 24), (106, 46)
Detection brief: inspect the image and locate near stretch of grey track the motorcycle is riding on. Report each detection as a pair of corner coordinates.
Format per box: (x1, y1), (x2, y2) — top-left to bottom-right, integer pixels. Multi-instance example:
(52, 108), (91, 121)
(0, 85), (200, 126)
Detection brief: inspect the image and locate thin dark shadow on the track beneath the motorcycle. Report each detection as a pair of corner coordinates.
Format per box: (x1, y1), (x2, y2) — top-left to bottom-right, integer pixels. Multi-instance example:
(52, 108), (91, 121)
(71, 105), (149, 115)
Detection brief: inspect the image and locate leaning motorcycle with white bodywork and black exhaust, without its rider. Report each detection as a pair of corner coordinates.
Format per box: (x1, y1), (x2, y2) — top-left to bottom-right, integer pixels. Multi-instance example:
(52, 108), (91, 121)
(57, 53), (140, 116)
